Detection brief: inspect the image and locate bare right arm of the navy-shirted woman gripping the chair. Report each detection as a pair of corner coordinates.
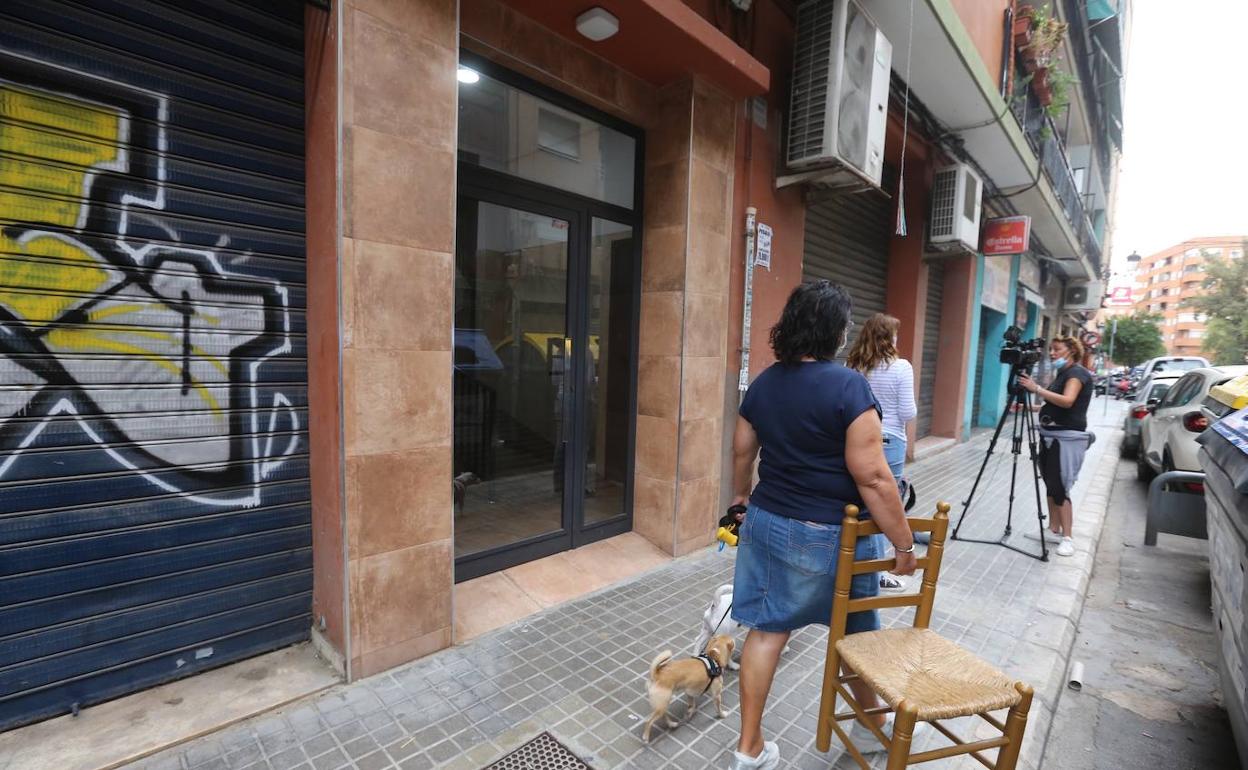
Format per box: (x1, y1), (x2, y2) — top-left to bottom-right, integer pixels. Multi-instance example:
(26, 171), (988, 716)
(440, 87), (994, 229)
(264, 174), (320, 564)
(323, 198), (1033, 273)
(845, 409), (915, 575)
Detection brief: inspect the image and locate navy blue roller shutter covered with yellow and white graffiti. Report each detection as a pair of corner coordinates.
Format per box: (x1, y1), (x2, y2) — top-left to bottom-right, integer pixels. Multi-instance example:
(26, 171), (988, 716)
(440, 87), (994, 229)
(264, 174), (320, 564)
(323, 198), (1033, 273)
(0, 0), (312, 730)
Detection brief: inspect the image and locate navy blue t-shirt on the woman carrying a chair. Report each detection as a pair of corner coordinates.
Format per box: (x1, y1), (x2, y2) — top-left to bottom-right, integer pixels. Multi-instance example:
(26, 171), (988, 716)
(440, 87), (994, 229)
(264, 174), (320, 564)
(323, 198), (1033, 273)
(740, 361), (880, 524)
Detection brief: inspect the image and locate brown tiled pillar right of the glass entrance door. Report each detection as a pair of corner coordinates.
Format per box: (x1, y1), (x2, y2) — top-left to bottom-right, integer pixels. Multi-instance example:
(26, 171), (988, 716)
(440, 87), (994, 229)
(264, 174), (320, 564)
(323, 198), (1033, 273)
(634, 80), (736, 554)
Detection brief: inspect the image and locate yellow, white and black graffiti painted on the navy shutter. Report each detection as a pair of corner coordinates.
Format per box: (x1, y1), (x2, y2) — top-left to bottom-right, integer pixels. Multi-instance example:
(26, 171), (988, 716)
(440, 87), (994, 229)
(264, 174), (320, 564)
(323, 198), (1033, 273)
(0, 55), (300, 499)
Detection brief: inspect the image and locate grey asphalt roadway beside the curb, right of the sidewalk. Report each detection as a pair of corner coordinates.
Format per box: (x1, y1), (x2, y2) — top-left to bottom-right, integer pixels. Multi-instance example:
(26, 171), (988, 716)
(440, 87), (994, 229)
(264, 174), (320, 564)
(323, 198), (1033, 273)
(1045, 461), (1241, 770)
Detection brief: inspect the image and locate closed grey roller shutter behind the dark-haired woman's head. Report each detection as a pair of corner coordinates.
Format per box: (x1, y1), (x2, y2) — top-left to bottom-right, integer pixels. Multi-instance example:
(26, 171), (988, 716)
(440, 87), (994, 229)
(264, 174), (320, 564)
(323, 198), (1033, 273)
(802, 192), (892, 344)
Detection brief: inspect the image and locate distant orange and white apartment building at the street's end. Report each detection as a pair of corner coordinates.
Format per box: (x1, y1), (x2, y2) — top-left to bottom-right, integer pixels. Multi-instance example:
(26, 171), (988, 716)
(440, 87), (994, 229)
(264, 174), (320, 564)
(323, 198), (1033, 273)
(1134, 236), (1248, 361)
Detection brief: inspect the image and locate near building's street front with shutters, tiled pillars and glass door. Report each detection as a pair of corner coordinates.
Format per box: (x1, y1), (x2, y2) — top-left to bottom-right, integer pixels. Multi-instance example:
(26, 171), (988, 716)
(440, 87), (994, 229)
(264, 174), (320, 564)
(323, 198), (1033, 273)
(0, 0), (1129, 729)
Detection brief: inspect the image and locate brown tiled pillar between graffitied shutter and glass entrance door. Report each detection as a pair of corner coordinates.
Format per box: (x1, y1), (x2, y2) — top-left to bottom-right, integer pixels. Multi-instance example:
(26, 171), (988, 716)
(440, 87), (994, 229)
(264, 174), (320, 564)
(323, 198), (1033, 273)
(341, 0), (458, 678)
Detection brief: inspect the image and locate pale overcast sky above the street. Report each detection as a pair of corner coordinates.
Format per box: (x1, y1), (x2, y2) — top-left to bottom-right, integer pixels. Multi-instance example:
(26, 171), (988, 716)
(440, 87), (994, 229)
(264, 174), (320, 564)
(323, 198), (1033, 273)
(1112, 0), (1248, 271)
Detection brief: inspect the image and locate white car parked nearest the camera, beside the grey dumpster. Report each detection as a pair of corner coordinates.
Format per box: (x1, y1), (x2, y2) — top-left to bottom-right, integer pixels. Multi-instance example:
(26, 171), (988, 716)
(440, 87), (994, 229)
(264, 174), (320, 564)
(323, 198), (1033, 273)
(1136, 366), (1248, 482)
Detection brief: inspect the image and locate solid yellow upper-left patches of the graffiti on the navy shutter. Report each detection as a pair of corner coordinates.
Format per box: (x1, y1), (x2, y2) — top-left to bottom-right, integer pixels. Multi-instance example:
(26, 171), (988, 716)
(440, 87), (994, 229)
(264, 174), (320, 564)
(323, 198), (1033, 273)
(0, 85), (122, 326)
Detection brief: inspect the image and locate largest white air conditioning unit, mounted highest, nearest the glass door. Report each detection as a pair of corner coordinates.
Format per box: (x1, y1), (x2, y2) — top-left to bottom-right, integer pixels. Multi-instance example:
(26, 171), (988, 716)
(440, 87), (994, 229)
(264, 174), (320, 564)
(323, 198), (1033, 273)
(776, 0), (892, 187)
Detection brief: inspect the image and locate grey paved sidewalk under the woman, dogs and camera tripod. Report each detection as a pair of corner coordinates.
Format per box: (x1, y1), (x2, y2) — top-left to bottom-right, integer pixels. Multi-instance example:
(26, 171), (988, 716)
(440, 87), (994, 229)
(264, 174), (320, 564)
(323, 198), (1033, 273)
(130, 399), (1123, 770)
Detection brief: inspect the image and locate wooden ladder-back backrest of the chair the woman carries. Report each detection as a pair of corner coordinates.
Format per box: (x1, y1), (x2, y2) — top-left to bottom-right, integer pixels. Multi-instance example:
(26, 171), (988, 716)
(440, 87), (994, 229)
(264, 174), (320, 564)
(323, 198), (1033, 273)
(829, 503), (950, 641)
